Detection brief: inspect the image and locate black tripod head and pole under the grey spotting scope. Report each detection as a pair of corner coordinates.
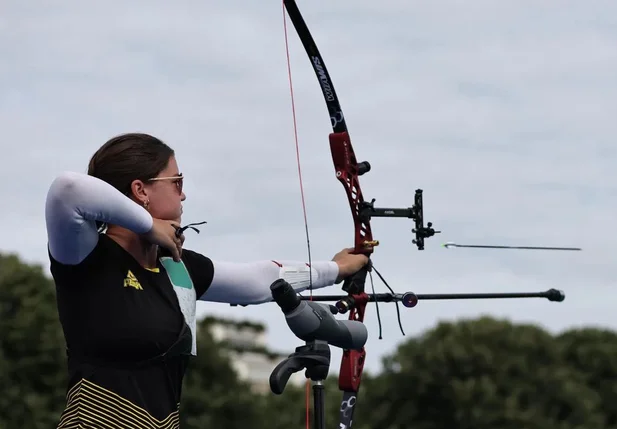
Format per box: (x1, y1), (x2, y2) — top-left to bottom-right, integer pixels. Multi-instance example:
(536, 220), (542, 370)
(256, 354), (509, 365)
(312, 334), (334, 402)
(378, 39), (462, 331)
(270, 341), (330, 429)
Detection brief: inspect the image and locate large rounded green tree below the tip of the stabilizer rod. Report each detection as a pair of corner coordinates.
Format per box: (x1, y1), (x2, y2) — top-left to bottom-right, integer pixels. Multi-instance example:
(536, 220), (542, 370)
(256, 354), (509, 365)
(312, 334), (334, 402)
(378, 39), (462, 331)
(364, 318), (603, 429)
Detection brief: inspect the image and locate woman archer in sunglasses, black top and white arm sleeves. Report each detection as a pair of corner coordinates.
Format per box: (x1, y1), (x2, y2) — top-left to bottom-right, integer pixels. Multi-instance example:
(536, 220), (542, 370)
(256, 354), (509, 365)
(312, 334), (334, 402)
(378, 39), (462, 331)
(45, 133), (368, 428)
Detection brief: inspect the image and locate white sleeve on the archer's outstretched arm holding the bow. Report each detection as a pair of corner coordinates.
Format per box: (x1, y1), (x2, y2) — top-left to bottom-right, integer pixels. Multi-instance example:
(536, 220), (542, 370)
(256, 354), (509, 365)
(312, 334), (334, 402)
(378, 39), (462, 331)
(199, 261), (339, 305)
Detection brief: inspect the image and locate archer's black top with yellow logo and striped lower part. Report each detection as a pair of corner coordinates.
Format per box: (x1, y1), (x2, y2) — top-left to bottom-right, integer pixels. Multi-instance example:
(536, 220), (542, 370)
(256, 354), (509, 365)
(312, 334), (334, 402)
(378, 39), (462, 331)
(49, 234), (214, 429)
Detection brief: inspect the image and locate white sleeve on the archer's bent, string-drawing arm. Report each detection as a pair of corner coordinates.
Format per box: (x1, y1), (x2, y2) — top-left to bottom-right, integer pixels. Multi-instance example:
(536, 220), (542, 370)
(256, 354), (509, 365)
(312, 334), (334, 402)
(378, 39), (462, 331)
(45, 172), (152, 265)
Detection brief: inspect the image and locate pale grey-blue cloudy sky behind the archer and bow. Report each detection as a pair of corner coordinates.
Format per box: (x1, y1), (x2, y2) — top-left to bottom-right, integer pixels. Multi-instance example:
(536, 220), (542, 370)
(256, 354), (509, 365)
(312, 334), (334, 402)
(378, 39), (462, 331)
(0, 0), (617, 372)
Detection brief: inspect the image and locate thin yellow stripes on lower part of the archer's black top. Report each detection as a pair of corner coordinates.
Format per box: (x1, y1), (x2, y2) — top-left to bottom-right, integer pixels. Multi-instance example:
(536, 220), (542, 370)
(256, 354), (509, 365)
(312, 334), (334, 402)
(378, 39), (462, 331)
(57, 379), (180, 429)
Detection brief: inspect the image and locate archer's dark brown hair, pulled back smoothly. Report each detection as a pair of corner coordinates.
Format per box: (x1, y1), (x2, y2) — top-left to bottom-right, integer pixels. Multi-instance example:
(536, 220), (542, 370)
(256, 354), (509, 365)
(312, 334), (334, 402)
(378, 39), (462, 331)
(88, 133), (174, 196)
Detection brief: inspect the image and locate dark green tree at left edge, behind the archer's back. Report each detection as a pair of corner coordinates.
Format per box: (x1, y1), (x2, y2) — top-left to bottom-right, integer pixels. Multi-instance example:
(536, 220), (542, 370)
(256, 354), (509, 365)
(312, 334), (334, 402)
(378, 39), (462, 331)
(0, 254), (66, 429)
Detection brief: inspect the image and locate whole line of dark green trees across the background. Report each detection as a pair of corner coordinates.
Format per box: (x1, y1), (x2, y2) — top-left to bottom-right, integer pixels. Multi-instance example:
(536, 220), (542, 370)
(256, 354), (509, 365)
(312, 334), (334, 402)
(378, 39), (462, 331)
(0, 251), (617, 429)
